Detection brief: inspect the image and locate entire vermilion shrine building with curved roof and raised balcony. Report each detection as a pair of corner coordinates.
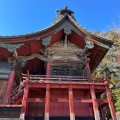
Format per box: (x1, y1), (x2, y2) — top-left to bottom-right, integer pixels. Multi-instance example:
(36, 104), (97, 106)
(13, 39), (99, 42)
(0, 6), (116, 120)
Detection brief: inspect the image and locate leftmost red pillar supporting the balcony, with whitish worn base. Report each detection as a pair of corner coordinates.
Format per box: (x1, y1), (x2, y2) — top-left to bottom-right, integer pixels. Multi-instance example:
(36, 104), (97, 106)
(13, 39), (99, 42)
(20, 84), (29, 120)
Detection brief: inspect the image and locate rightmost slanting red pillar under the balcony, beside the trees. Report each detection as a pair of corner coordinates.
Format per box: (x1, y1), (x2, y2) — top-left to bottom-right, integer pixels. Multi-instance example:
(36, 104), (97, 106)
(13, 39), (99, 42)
(105, 86), (116, 120)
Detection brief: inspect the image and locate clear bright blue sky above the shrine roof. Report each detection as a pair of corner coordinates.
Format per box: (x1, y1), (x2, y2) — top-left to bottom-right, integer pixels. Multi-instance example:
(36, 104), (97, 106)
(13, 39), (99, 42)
(0, 0), (120, 36)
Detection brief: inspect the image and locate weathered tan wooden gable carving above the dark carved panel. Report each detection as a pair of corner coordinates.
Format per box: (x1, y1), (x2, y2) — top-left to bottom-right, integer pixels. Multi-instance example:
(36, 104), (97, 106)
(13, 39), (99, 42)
(46, 36), (86, 62)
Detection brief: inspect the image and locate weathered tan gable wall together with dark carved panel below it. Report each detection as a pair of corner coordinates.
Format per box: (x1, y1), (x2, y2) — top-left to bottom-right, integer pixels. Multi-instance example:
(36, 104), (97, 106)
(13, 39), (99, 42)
(46, 39), (86, 76)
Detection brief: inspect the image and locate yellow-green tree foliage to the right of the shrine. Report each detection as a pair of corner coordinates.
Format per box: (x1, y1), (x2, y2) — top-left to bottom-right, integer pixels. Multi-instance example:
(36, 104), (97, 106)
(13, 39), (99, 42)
(93, 30), (120, 112)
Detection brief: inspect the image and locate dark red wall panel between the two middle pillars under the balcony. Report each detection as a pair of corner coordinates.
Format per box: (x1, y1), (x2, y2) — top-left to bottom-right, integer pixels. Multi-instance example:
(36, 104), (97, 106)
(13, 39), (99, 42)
(50, 88), (70, 116)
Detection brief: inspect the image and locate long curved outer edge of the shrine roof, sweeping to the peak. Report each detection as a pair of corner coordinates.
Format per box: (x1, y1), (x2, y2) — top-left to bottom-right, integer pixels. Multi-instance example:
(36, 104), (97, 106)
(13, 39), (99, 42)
(0, 14), (113, 46)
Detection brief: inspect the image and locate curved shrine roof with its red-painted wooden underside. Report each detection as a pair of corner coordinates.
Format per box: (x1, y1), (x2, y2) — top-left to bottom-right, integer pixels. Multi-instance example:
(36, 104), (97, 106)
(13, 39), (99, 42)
(0, 8), (113, 73)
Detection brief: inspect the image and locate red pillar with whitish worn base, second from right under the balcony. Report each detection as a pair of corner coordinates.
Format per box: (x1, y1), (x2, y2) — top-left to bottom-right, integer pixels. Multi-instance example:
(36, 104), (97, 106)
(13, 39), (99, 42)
(90, 86), (100, 120)
